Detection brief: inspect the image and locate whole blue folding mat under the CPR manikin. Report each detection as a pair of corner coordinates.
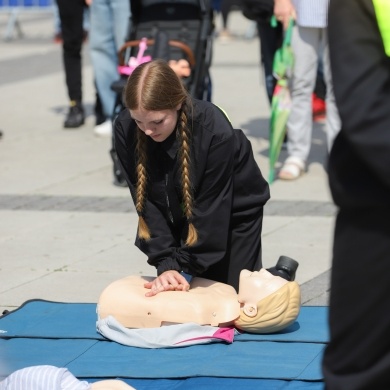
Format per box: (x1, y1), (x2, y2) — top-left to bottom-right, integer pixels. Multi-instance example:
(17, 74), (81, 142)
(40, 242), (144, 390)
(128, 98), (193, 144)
(0, 300), (328, 390)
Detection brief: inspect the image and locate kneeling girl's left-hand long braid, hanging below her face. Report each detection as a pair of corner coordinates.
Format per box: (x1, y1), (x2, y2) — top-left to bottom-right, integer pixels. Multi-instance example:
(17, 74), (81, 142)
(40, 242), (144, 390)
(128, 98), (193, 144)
(135, 130), (150, 240)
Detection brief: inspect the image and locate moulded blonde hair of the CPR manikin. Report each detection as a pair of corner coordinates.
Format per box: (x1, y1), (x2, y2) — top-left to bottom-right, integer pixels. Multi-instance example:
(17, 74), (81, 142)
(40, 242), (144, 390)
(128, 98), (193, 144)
(234, 282), (301, 333)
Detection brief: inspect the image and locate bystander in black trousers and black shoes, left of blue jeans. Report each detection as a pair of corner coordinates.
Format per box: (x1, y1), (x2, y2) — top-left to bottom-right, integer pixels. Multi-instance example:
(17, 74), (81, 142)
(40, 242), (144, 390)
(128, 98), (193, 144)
(57, 0), (86, 128)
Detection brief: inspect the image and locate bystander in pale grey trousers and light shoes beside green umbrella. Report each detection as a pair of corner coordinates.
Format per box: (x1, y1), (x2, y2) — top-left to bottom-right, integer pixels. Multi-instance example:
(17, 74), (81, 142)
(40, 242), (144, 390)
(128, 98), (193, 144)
(274, 0), (340, 180)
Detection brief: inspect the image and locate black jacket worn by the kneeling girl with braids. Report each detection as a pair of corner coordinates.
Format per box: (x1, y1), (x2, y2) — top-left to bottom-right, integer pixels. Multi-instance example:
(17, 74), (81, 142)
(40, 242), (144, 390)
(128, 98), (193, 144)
(115, 100), (269, 275)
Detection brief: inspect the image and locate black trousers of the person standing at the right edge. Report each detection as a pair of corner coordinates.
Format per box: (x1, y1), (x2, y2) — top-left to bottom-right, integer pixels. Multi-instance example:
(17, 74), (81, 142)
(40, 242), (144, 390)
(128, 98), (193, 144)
(323, 210), (390, 390)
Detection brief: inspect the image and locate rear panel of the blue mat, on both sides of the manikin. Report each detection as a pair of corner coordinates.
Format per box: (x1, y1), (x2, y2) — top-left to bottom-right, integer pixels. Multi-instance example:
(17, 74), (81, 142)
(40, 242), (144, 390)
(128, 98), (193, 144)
(0, 299), (328, 343)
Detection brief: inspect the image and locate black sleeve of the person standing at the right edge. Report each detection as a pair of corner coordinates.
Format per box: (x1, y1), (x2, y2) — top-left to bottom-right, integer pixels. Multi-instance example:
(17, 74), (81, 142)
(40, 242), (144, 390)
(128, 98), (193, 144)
(328, 0), (390, 189)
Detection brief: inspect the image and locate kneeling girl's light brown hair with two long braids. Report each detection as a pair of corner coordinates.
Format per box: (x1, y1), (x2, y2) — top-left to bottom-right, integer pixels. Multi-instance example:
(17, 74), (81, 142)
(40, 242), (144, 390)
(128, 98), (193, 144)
(124, 59), (198, 246)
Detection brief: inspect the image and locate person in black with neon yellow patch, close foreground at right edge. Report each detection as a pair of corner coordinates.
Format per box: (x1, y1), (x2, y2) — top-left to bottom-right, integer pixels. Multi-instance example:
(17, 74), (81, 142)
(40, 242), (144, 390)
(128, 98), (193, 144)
(323, 0), (390, 390)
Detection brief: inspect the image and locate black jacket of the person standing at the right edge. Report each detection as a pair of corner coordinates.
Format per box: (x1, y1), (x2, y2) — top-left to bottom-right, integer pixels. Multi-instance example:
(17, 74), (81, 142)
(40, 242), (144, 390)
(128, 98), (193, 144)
(328, 0), (390, 209)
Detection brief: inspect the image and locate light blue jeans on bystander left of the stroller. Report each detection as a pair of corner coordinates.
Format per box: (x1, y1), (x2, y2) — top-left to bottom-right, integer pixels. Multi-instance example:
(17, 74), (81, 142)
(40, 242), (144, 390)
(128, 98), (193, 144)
(89, 0), (131, 118)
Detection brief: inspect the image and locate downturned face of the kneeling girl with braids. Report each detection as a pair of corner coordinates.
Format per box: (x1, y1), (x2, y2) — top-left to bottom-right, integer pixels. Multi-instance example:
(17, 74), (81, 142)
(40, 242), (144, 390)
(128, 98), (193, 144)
(130, 105), (180, 142)
